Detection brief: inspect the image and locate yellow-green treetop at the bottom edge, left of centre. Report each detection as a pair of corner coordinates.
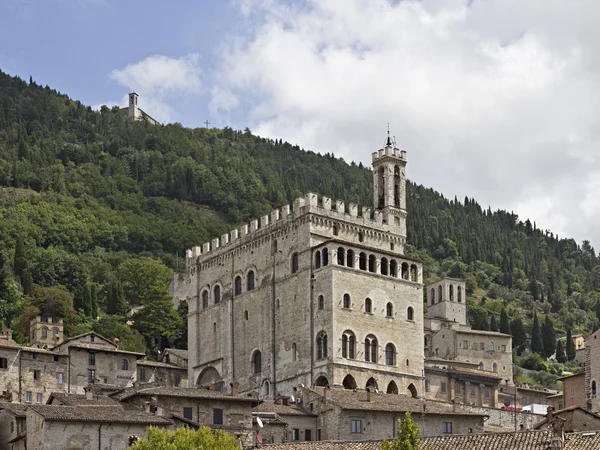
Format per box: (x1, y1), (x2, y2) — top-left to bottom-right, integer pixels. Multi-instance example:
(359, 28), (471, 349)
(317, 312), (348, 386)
(133, 426), (240, 450)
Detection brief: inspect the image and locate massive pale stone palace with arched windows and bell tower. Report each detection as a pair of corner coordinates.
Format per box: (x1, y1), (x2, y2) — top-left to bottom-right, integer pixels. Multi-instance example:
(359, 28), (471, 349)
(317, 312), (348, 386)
(184, 139), (423, 398)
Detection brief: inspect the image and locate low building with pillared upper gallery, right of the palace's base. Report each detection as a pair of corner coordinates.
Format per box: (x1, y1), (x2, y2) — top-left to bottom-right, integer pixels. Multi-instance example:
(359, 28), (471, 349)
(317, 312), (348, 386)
(425, 358), (502, 408)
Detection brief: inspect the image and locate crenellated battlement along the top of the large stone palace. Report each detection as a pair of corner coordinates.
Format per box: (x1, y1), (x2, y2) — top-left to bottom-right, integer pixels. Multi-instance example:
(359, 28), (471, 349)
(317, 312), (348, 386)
(186, 192), (406, 268)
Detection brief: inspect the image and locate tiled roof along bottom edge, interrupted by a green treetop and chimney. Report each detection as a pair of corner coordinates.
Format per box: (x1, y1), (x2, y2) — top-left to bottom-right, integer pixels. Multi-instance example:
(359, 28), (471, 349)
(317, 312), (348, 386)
(261, 431), (600, 450)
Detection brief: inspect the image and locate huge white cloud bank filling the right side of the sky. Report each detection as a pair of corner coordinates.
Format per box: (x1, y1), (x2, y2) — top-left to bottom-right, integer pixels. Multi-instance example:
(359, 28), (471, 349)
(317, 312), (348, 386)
(212, 0), (600, 247)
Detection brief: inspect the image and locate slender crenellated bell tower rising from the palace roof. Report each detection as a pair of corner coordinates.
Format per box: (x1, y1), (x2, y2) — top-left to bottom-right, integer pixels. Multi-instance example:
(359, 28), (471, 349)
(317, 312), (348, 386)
(372, 129), (406, 237)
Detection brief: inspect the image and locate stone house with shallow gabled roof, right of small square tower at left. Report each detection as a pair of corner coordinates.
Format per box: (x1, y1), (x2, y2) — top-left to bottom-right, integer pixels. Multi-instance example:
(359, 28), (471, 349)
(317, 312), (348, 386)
(53, 332), (145, 393)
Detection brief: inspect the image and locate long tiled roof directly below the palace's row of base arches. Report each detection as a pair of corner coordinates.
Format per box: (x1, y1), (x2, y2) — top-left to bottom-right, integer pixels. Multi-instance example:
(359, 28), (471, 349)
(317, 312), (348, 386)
(307, 387), (486, 416)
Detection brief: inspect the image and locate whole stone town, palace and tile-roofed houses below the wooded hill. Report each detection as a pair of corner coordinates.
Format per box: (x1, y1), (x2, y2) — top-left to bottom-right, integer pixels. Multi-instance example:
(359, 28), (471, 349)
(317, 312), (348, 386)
(0, 116), (600, 450)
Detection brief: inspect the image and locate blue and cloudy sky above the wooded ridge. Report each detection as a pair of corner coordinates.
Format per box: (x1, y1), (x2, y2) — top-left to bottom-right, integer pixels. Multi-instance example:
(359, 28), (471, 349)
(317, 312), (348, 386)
(0, 0), (600, 249)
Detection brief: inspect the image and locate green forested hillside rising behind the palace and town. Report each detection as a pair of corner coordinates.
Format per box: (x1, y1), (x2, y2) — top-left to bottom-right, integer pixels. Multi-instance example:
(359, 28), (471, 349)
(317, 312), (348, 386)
(0, 72), (600, 376)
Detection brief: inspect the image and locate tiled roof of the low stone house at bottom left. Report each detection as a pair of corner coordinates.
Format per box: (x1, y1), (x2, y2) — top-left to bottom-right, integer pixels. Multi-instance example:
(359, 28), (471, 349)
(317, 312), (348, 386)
(30, 405), (171, 425)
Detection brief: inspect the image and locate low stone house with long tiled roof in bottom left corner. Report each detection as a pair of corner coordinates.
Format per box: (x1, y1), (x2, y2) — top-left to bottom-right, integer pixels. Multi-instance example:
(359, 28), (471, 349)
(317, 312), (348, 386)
(27, 405), (172, 450)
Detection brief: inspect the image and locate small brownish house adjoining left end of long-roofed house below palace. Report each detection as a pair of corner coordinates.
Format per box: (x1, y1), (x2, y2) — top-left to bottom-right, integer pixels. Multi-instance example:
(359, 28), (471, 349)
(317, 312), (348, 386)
(252, 398), (317, 444)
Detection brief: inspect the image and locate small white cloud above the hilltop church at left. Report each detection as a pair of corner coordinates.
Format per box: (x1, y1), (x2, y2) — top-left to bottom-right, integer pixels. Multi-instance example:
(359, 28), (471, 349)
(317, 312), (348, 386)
(110, 53), (202, 122)
